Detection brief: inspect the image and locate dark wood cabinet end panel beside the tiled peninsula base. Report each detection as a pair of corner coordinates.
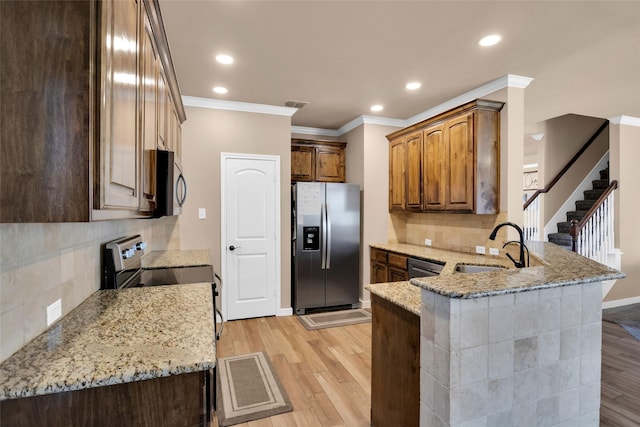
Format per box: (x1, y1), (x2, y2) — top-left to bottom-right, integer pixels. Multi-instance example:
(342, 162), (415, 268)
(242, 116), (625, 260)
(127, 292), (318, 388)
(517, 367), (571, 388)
(371, 294), (420, 427)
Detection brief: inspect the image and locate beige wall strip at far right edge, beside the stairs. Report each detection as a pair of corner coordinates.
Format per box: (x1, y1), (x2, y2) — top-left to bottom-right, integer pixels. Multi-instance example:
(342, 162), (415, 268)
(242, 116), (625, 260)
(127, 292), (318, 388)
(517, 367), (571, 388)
(605, 124), (640, 302)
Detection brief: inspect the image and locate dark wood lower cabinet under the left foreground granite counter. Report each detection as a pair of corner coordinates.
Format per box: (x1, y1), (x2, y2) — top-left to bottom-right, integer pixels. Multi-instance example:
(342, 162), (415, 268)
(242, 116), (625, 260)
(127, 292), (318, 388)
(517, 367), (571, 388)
(0, 372), (210, 427)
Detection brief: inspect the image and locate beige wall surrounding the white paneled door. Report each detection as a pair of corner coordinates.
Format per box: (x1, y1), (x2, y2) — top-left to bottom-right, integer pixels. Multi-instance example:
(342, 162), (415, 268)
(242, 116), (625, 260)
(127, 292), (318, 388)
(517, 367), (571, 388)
(180, 107), (291, 309)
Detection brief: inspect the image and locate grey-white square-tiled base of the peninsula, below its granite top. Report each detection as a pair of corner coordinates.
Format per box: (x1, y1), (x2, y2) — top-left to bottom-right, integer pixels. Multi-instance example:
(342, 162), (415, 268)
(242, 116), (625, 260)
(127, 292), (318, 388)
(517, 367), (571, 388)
(420, 282), (602, 427)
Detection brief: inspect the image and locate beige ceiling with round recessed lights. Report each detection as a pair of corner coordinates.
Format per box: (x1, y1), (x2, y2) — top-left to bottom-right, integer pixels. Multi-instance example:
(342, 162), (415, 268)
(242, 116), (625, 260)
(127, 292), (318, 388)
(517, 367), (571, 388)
(160, 0), (640, 132)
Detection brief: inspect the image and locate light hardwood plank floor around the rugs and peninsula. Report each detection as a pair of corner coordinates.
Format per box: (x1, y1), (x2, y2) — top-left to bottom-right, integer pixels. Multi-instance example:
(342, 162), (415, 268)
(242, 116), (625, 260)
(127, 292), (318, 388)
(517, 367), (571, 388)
(211, 316), (640, 427)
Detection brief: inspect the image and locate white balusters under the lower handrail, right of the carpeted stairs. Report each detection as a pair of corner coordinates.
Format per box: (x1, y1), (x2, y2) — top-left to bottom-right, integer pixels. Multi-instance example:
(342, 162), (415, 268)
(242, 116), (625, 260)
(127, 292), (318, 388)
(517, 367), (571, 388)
(569, 180), (618, 264)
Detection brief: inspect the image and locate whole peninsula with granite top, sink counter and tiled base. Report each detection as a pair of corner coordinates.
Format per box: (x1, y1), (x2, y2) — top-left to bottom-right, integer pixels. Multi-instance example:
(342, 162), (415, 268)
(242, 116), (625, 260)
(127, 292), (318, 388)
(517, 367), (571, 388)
(367, 242), (624, 426)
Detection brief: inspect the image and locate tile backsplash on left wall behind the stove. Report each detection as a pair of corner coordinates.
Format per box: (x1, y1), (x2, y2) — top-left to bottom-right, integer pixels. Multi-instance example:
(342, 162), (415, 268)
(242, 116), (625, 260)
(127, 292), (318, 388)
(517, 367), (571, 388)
(0, 217), (180, 361)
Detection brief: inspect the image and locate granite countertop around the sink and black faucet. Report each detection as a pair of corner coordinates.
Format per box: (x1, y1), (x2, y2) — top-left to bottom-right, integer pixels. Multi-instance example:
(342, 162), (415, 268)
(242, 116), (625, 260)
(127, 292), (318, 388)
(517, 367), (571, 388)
(366, 241), (625, 306)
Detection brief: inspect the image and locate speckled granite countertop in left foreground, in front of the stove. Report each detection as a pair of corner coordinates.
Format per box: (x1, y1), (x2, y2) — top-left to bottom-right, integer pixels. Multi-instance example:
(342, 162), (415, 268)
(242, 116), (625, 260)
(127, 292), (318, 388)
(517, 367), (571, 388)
(0, 284), (216, 400)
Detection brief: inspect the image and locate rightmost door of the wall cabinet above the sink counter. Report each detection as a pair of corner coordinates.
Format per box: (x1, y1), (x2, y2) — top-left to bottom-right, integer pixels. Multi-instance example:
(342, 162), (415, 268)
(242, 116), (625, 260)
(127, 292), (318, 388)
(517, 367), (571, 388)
(445, 113), (474, 212)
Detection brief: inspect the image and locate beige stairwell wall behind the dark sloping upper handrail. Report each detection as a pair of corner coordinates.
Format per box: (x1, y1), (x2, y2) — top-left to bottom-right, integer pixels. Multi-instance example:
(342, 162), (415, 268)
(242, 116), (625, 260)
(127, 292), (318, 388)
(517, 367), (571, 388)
(539, 114), (609, 224)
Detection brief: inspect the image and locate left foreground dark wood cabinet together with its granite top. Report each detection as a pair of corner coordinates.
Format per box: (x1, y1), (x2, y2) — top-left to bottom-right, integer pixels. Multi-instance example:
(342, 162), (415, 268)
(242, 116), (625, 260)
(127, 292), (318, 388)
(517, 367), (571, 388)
(0, 283), (216, 426)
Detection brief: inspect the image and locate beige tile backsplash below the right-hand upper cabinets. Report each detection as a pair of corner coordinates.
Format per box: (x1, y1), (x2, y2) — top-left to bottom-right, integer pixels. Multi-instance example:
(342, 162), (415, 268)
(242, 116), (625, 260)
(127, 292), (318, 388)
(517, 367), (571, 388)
(389, 212), (507, 253)
